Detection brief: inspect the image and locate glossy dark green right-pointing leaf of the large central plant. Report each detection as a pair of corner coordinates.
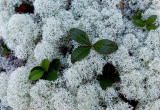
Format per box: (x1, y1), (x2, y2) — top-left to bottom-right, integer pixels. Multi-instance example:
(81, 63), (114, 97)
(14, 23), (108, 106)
(93, 39), (118, 54)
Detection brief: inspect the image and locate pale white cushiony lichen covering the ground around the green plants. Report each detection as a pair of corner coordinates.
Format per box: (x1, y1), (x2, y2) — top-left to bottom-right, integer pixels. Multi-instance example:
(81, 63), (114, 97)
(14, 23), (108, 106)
(0, 0), (160, 110)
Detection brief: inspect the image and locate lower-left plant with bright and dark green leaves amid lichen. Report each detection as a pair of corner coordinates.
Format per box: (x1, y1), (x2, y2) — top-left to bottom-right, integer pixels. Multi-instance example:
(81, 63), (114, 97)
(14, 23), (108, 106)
(29, 59), (61, 81)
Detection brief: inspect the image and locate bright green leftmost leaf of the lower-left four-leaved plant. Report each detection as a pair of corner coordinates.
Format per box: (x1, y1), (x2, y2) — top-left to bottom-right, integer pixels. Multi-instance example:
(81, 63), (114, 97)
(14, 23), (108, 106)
(29, 70), (44, 80)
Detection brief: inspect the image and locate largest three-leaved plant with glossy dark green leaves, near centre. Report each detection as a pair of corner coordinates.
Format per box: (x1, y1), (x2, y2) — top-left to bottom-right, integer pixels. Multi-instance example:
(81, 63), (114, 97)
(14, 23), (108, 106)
(69, 28), (118, 63)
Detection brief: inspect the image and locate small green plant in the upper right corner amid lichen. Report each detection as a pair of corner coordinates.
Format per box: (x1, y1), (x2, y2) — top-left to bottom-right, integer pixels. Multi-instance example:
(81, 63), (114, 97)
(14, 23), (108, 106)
(132, 10), (157, 31)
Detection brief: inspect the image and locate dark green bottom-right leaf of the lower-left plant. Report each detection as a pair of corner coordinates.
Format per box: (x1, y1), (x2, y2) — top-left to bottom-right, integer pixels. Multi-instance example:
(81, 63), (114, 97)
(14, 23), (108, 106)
(43, 68), (58, 81)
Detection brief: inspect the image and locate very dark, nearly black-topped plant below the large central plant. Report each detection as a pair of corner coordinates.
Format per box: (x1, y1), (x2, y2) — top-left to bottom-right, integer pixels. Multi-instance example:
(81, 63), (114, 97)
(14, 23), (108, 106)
(97, 63), (120, 90)
